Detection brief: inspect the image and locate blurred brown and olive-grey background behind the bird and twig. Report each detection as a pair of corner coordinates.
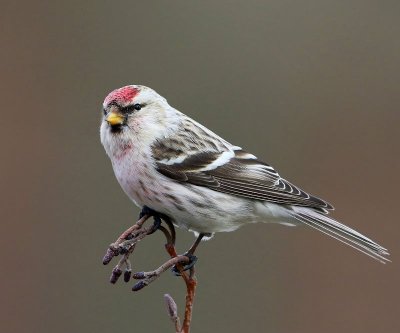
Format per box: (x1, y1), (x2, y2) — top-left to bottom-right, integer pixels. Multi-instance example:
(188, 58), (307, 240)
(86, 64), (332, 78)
(0, 0), (400, 333)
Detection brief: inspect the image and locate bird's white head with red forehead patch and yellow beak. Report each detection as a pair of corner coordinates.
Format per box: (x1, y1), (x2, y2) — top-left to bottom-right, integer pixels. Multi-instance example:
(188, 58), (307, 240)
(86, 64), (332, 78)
(100, 85), (175, 155)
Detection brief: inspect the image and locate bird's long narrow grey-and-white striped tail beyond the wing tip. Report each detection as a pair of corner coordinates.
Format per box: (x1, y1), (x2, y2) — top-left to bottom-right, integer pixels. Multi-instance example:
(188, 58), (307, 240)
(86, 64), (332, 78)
(289, 206), (390, 263)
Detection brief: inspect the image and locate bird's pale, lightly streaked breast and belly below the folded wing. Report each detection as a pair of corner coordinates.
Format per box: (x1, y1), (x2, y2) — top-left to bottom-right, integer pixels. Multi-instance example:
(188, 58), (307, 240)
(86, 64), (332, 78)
(113, 150), (290, 233)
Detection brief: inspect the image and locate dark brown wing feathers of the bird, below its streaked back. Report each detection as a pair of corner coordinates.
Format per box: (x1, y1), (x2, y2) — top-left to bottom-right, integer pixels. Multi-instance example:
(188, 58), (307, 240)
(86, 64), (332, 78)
(156, 150), (333, 212)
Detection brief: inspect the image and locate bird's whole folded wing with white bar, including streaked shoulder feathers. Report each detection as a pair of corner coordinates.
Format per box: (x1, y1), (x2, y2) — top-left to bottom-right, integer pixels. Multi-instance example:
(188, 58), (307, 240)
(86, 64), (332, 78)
(152, 121), (333, 213)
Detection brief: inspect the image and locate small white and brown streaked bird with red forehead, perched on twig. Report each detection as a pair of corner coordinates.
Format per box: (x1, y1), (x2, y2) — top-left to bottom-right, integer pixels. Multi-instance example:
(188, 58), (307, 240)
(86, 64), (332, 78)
(100, 85), (389, 263)
